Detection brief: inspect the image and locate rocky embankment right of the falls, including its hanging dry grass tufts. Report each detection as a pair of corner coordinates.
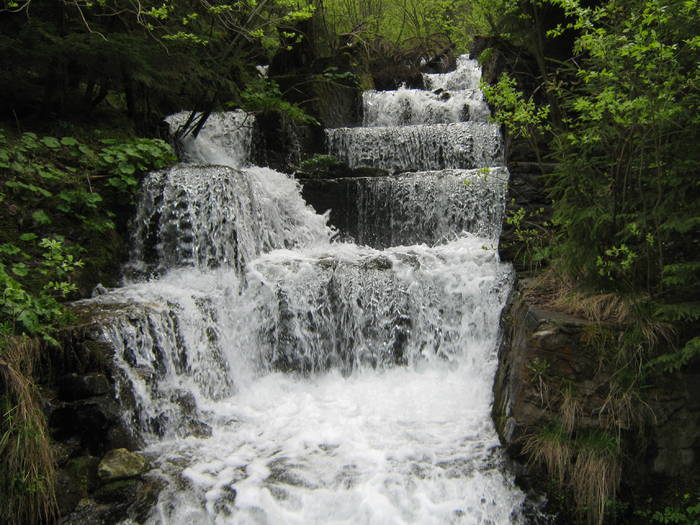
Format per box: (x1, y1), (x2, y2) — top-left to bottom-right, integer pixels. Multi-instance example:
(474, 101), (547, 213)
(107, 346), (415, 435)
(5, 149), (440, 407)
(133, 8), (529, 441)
(493, 279), (700, 523)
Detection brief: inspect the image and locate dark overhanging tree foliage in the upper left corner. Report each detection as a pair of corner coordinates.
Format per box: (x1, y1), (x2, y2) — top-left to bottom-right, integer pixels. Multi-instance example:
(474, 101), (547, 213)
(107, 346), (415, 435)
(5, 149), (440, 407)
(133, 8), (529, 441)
(0, 0), (314, 128)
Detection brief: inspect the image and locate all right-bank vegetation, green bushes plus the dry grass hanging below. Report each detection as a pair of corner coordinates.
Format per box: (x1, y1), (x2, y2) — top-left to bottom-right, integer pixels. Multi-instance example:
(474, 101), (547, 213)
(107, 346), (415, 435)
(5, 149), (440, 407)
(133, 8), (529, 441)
(484, 0), (700, 523)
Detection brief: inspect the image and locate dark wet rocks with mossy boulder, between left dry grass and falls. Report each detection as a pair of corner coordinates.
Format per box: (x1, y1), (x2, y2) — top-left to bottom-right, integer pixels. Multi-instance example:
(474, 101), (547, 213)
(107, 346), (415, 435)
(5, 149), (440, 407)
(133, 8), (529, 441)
(44, 309), (162, 525)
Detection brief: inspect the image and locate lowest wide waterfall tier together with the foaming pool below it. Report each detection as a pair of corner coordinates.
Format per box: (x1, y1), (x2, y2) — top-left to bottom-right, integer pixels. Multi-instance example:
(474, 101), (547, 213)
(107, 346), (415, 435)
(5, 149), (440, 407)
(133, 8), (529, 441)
(90, 237), (522, 524)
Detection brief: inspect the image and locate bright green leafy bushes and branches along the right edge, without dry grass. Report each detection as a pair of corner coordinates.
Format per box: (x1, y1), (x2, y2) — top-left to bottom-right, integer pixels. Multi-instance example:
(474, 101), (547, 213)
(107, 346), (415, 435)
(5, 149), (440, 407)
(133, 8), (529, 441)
(550, 0), (700, 370)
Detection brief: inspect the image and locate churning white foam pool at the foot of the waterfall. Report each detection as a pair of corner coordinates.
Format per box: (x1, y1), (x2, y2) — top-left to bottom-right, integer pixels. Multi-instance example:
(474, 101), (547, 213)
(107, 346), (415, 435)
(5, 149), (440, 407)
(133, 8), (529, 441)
(152, 364), (522, 525)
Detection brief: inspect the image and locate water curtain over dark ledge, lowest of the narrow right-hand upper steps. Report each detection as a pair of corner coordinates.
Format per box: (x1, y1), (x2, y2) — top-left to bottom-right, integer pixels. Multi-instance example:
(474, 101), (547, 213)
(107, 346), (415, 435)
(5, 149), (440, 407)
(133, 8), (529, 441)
(326, 168), (509, 248)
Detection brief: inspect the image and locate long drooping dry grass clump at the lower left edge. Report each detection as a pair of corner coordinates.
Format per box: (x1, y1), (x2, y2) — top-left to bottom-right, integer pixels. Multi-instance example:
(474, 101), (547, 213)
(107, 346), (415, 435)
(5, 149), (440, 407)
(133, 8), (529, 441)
(0, 338), (57, 524)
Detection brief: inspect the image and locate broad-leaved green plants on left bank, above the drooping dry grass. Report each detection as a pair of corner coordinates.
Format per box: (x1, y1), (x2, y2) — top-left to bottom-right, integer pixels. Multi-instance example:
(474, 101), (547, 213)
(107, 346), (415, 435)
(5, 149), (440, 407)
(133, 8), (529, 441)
(0, 130), (175, 343)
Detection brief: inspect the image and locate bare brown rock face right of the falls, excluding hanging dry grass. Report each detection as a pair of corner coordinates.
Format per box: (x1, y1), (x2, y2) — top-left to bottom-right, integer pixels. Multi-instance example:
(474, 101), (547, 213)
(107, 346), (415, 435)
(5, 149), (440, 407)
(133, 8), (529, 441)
(493, 283), (700, 512)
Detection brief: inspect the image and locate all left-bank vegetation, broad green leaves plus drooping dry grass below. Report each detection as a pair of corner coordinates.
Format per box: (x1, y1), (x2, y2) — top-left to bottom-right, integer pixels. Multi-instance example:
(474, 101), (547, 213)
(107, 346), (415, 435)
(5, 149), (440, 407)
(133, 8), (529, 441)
(0, 126), (175, 523)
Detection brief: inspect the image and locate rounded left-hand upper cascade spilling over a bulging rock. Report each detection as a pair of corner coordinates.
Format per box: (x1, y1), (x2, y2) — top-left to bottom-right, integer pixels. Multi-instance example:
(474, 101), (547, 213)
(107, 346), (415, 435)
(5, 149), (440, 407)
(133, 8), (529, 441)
(129, 112), (332, 276)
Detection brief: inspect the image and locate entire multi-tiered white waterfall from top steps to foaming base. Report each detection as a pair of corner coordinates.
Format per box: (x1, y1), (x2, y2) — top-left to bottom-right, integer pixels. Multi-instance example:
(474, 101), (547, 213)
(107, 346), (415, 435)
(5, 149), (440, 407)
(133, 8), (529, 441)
(82, 55), (524, 525)
